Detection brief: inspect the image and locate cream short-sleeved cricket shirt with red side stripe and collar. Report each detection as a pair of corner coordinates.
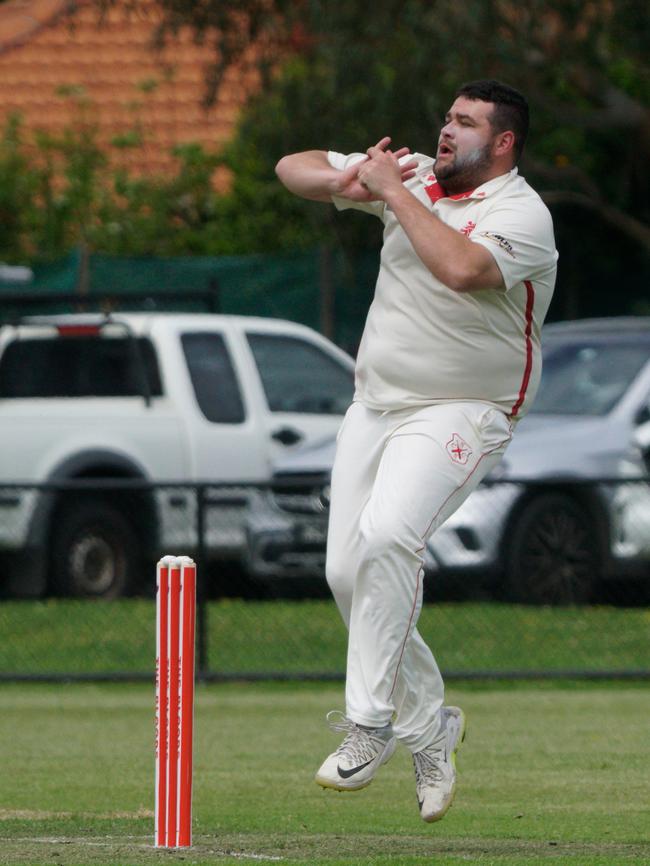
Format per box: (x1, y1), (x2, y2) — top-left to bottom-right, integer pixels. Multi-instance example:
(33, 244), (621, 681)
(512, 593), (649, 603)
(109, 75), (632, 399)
(328, 151), (557, 418)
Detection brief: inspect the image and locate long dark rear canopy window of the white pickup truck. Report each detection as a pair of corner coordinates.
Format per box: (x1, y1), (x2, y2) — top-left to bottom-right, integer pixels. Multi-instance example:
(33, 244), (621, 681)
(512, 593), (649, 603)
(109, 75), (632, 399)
(0, 335), (162, 398)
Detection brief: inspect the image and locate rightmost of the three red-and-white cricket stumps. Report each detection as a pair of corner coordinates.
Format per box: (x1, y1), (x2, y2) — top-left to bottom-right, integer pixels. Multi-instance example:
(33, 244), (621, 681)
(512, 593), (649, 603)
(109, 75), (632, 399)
(176, 563), (196, 847)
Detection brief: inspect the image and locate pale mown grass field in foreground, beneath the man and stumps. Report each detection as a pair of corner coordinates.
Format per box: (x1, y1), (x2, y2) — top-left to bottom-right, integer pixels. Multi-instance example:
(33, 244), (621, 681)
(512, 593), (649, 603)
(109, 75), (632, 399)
(0, 682), (650, 866)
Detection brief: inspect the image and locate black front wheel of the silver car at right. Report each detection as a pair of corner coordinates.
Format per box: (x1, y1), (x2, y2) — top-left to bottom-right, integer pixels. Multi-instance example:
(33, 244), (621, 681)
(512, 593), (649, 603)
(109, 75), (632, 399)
(505, 493), (601, 604)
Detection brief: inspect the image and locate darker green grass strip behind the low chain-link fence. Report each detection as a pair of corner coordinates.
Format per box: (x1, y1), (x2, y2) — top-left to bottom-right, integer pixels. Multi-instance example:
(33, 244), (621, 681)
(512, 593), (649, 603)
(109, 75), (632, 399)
(0, 599), (650, 675)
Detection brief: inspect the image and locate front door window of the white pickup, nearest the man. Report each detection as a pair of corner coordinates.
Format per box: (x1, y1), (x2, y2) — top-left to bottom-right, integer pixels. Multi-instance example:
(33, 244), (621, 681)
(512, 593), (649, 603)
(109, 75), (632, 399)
(247, 334), (354, 415)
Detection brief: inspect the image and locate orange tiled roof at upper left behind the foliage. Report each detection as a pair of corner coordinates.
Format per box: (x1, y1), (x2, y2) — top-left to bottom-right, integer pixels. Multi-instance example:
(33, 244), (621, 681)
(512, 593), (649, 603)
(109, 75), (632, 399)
(0, 0), (256, 173)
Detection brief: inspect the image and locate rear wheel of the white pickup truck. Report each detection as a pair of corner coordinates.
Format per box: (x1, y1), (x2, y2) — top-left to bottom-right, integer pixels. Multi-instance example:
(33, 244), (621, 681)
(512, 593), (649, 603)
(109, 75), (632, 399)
(51, 500), (138, 599)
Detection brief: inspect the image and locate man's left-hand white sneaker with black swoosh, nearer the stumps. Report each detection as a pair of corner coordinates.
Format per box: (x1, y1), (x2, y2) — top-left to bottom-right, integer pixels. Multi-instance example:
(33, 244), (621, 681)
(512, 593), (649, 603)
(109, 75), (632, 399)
(316, 710), (397, 791)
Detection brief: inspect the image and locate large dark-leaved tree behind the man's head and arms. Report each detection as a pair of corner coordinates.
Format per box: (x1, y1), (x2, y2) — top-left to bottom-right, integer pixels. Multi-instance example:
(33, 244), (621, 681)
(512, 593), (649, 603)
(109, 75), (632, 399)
(130, 0), (650, 315)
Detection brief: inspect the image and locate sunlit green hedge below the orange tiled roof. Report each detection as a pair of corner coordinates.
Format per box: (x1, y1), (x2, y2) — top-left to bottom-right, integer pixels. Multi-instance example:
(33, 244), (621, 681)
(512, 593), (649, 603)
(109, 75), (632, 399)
(0, 87), (252, 262)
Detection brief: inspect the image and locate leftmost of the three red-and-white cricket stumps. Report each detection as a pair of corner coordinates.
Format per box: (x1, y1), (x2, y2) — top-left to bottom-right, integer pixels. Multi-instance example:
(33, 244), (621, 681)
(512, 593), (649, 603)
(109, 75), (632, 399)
(154, 562), (169, 848)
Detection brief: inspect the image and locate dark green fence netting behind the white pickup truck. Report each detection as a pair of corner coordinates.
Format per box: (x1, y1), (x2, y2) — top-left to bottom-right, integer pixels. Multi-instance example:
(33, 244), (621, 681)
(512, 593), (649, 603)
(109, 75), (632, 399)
(0, 249), (378, 351)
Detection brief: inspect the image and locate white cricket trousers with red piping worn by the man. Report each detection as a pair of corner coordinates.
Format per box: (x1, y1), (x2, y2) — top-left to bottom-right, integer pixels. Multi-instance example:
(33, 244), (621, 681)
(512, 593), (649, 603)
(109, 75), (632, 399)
(326, 401), (512, 752)
